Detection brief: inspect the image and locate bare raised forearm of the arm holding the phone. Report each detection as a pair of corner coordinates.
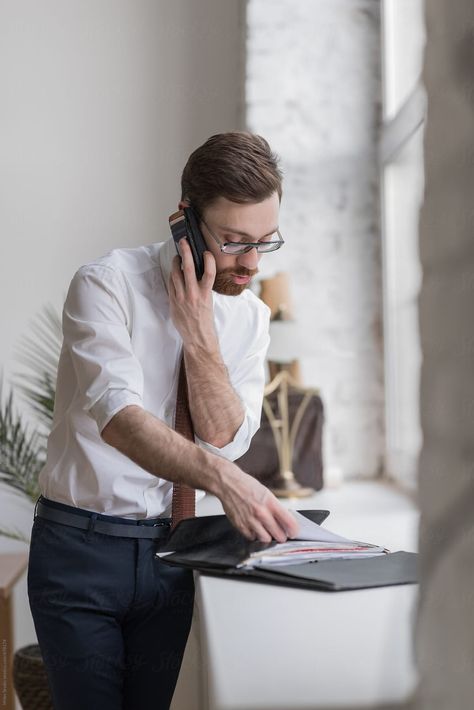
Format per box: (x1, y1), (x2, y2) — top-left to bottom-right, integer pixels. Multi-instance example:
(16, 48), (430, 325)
(184, 338), (245, 448)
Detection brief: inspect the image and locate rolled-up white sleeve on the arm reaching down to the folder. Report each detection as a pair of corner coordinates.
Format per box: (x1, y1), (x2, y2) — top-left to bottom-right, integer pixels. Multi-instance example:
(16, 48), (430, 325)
(62, 264), (144, 432)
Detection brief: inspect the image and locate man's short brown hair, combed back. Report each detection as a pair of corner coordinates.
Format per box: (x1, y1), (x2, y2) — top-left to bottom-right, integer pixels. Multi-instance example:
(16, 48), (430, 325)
(181, 131), (282, 215)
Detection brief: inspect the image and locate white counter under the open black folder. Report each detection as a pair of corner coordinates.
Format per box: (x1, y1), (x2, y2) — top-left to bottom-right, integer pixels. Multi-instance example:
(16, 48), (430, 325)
(172, 483), (418, 710)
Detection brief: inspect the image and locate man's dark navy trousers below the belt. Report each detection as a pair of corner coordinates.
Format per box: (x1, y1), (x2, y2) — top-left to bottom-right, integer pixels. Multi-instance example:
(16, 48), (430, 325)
(28, 503), (194, 710)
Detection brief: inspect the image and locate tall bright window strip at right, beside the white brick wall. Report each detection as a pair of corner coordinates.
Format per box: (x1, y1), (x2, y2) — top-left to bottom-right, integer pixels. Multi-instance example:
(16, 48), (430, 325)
(379, 0), (426, 487)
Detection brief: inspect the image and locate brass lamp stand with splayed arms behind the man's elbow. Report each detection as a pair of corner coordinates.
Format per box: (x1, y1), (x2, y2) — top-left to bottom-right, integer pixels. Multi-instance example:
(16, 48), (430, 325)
(263, 370), (317, 498)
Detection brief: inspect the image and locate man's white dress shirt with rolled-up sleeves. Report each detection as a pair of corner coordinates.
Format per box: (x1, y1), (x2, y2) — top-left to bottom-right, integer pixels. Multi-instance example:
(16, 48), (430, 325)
(39, 239), (270, 520)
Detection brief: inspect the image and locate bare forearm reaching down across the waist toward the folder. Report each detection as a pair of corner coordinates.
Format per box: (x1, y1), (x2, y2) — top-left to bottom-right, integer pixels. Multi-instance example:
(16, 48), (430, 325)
(102, 405), (230, 496)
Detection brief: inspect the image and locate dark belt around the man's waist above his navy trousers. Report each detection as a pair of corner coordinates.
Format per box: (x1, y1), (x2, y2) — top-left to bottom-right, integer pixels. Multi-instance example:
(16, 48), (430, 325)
(36, 500), (171, 540)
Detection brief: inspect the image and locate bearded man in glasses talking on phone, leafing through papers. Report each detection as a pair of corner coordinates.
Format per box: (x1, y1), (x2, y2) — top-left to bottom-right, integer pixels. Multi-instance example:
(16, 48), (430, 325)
(28, 133), (297, 710)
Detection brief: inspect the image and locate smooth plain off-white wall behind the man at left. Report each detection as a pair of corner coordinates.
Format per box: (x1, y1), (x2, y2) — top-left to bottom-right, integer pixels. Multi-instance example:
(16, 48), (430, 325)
(0, 0), (243, 692)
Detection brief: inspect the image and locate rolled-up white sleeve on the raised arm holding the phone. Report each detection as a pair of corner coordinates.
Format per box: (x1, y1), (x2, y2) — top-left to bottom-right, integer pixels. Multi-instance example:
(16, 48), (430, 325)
(195, 302), (270, 461)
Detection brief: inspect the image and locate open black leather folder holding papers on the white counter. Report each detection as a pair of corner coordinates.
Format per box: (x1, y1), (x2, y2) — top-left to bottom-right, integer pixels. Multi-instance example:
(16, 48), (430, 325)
(158, 510), (418, 591)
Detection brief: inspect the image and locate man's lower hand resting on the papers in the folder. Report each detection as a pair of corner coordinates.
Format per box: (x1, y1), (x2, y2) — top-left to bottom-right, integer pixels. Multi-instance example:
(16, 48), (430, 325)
(216, 462), (298, 542)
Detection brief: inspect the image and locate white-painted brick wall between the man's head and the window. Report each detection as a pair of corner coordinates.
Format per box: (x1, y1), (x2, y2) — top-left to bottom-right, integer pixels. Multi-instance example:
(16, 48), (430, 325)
(247, 0), (384, 477)
